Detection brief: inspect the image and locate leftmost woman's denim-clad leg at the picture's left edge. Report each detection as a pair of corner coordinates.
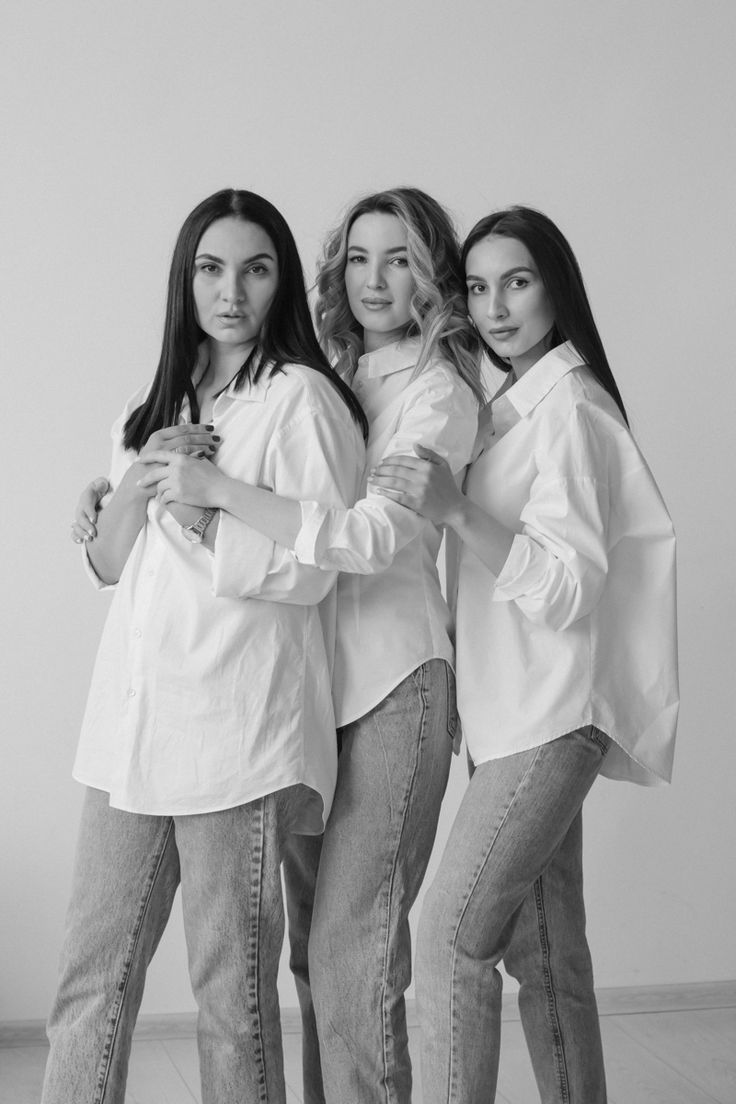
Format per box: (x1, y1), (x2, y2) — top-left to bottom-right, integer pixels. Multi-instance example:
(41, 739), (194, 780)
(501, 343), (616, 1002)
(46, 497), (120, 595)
(43, 789), (179, 1104)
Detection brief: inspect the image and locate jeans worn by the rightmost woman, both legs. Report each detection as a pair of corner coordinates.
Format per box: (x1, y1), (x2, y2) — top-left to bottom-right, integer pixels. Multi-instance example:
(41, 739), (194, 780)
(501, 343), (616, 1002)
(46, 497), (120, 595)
(416, 725), (609, 1104)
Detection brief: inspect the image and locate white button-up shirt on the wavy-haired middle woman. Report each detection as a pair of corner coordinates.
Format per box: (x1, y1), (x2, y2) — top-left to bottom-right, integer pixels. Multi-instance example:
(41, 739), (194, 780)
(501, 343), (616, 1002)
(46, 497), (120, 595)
(295, 339), (478, 725)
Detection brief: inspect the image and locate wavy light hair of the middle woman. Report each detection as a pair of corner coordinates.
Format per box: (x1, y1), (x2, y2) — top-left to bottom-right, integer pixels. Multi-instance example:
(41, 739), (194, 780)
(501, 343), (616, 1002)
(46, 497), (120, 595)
(314, 188), (486, 403)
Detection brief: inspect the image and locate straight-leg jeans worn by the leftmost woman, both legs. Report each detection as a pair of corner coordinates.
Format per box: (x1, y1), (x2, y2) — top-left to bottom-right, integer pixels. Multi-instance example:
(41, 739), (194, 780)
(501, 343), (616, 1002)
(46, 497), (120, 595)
(43, 787), (297, 1104)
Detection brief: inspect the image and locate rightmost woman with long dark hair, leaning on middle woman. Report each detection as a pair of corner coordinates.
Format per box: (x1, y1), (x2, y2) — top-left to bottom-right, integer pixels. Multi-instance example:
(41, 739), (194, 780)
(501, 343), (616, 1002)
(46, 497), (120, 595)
(372, 206), (679, 1104)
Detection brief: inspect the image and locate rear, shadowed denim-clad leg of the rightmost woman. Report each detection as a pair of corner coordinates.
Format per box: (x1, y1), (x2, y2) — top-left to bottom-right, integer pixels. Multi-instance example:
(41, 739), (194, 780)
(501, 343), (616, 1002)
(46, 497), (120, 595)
(503, 813), (606, 1104)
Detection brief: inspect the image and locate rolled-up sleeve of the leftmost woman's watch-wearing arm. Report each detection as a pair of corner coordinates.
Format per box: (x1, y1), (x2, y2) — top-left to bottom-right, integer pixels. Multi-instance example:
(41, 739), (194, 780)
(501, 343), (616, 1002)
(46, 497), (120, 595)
(213, 408), (364, 605)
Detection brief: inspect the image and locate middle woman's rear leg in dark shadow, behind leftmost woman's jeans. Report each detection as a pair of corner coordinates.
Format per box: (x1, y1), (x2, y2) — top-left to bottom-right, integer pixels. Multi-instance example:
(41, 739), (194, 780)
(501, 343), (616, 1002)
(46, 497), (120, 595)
(284, 832), (324, 1104)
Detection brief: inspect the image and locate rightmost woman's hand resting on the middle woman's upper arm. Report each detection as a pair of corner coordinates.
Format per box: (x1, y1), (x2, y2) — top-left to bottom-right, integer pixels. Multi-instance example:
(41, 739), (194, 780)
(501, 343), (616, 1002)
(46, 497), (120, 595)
(369, 445), (463, 524)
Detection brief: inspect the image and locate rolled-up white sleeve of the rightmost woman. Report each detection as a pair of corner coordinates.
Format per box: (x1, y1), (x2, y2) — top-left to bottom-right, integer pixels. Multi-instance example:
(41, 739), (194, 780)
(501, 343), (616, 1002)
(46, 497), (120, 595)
(493, 477), (609, 630)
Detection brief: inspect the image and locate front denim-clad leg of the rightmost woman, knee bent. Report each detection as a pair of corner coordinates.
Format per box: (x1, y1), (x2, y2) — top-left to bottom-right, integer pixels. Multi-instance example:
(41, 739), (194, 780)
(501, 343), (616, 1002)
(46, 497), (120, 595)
(417, 728), (606, 1104)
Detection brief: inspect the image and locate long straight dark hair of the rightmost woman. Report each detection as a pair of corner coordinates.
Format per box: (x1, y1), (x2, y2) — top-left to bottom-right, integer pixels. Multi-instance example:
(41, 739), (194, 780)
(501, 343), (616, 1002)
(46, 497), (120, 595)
(462, 206), (629, 425)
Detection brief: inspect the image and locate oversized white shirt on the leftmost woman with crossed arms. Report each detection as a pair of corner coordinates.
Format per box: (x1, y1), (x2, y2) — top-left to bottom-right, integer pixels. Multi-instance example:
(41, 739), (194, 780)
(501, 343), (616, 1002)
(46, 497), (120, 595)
(74, 364), (364, 832)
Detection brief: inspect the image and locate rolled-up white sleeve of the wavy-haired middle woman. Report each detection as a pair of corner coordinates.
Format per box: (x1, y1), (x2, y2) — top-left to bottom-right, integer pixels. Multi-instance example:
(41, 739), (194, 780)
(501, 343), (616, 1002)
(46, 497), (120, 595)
(295, 372), (478, 575)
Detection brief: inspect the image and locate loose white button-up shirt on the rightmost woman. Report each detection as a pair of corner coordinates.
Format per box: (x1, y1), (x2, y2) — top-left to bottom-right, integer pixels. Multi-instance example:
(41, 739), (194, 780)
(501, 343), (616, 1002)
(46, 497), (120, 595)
(457, 343), (679, 784)
